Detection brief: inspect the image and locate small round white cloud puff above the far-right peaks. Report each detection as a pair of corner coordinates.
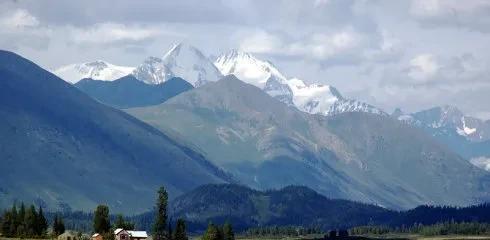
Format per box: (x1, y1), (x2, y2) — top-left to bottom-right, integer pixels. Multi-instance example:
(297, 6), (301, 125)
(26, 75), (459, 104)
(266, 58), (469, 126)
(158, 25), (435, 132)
(408, 54), (439, 80)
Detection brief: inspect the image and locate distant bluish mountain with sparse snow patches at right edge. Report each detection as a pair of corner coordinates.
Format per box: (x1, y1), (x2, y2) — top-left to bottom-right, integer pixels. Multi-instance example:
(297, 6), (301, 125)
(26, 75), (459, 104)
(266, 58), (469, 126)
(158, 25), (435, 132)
(392, 106), (490, 142)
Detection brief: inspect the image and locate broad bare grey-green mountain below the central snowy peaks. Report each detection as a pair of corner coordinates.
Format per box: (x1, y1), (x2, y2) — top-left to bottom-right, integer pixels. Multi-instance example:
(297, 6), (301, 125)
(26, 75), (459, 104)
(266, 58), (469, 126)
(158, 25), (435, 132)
(128, 75), (490, 209)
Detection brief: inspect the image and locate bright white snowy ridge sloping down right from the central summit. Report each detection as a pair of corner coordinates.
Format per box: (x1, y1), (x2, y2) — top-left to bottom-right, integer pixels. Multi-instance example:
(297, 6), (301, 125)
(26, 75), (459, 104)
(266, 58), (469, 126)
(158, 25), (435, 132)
(214, 50), (386, 115)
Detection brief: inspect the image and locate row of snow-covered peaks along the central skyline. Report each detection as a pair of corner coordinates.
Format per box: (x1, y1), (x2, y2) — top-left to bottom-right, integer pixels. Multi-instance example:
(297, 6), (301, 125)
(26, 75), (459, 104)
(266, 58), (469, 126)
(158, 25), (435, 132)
(54, 43), (387, 118)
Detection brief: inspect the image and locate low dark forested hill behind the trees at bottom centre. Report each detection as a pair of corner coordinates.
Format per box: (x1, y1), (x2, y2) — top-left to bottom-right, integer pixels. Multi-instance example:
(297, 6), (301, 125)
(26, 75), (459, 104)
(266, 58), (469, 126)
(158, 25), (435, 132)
(170, 184), (397, 230)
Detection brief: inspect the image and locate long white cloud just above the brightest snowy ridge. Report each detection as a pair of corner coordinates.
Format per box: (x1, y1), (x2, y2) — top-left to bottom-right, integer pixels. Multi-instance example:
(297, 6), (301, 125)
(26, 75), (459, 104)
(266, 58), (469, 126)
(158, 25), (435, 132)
(239, 27), (390, 65)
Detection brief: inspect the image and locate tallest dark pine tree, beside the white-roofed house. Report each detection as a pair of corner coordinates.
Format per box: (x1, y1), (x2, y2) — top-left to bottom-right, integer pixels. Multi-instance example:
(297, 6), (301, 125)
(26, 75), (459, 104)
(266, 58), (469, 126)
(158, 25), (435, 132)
(153, 187), (168, 240)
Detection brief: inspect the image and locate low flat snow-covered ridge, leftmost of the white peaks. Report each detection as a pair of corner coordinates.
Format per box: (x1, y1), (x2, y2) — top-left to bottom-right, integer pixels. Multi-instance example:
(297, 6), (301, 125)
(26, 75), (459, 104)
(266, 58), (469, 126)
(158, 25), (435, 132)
(53, 60), (134, 84)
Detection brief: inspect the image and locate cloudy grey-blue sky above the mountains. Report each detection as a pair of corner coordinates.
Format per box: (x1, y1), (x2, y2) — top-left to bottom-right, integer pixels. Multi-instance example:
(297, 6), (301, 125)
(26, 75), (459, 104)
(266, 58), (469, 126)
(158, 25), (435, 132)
(0, 0), (490, 119)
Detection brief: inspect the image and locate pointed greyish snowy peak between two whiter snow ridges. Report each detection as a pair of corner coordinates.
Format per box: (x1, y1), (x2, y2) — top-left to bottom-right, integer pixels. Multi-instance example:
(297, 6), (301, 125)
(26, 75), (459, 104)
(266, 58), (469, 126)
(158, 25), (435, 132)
(133, 43), (222, 87)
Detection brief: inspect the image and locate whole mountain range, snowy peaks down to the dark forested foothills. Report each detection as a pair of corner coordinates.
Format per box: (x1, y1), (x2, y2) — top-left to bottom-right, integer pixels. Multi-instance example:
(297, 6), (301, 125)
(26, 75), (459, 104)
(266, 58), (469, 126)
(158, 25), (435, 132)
(0, 44), (490, 212)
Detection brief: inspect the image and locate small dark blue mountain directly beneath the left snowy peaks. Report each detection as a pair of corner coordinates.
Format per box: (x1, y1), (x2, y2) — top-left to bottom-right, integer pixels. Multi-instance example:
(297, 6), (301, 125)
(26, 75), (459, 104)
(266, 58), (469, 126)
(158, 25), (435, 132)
(75, 75), (193, 108)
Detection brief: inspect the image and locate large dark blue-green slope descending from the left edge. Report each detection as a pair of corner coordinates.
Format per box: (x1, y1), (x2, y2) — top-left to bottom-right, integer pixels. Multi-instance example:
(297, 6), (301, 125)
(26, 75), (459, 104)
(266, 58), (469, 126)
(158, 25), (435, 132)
(0, 51), (233, 214)
